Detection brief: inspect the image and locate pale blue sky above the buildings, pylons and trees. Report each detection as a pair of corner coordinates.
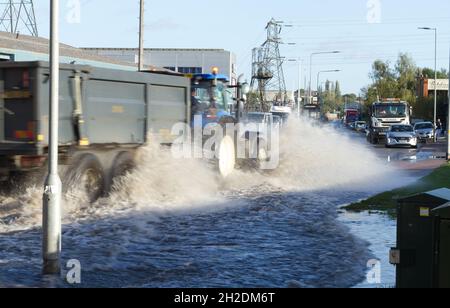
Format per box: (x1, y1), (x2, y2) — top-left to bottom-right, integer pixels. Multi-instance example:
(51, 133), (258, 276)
(28, 0), (450, 94)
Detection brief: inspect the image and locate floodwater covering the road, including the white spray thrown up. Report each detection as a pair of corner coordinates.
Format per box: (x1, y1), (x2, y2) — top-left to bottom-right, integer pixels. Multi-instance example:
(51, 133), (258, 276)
(0, 122), (422, 287)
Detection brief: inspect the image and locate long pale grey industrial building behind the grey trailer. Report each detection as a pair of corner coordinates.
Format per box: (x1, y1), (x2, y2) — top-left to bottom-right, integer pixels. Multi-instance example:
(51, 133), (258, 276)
(83, 48), (237, 84)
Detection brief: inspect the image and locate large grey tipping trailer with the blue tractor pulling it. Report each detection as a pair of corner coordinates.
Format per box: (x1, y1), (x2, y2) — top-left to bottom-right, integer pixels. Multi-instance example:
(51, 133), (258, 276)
(0, 62), (260, 202)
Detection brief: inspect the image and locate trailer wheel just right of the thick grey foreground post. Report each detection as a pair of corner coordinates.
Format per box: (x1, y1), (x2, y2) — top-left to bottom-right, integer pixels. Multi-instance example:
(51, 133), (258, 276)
(63, 154), (105, 203)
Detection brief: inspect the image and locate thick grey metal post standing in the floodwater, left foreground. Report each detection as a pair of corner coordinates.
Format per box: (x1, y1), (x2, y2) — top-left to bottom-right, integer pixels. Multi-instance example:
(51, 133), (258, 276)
(42, 0), (62, 275)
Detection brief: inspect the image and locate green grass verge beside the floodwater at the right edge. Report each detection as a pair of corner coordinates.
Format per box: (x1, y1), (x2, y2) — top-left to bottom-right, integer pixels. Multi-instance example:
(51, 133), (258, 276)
(344, 164), (450, 212)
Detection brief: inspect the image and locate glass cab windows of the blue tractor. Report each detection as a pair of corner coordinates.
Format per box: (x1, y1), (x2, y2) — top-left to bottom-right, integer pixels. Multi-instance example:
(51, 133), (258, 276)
(192, 81), (232, 114)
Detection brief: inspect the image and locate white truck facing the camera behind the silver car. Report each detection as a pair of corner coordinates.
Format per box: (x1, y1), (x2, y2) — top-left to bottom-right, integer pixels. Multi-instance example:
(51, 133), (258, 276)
(367, 99), (411, 144)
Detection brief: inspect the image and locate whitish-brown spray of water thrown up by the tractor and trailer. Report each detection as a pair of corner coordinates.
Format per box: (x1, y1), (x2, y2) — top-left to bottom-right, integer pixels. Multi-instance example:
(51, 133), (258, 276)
(0, 119), (406, 232)
